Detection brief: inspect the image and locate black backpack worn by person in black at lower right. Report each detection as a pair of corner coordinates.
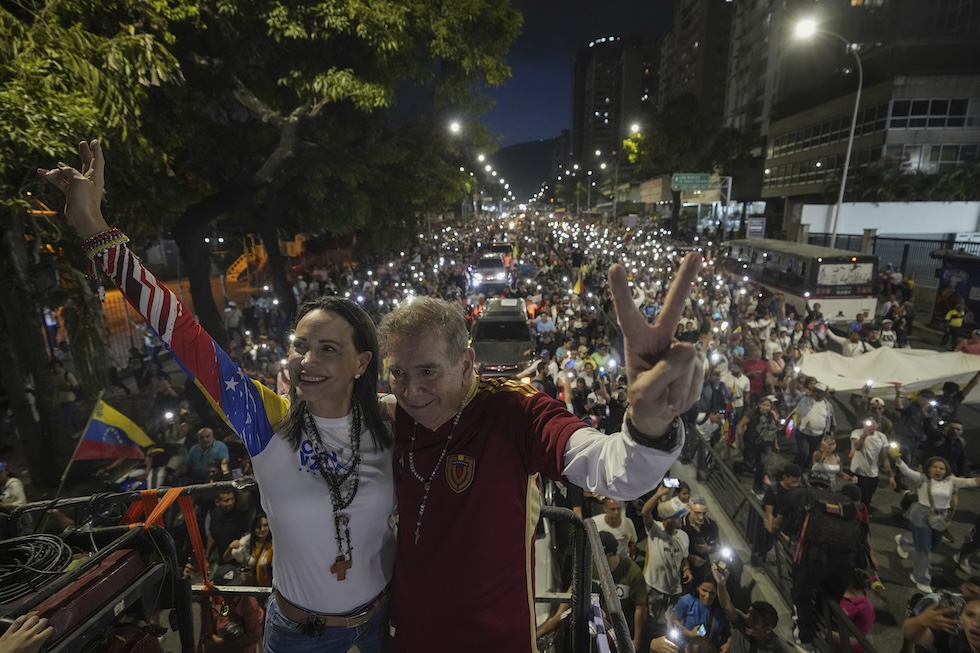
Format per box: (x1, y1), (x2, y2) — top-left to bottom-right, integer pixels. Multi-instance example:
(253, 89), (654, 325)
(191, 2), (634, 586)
(796, 488), (864, 557)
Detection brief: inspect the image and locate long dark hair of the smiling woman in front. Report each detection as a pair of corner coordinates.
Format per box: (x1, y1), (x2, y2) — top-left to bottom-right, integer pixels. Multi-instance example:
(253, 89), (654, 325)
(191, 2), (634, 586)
(277, 295), (392, 451)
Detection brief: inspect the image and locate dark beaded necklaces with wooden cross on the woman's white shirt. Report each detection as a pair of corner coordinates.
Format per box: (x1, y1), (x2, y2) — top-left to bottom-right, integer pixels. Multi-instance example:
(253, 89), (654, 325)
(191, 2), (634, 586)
(303, 401), (361, 580)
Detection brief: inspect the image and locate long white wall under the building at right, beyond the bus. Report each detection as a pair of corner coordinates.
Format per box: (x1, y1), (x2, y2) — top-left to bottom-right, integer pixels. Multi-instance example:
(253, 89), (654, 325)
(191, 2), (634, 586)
(800, 202), (980, 237)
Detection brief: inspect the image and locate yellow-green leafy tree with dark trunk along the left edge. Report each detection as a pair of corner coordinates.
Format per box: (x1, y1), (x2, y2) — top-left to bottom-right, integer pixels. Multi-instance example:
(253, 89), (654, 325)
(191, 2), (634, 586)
(0, 0), (186, 484)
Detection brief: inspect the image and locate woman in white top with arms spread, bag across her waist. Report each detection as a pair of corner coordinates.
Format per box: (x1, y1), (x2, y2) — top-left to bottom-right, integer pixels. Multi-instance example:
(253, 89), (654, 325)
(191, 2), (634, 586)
(890, 449), (980, 594)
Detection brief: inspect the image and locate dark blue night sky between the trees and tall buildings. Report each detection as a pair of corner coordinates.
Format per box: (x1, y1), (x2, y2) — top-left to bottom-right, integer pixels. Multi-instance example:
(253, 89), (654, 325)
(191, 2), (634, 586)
(483, 0), (673, 147)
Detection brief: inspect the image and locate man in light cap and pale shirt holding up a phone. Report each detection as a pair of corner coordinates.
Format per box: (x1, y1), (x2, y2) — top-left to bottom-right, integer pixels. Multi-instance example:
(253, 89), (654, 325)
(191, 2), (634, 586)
(638, 485), (694, 650)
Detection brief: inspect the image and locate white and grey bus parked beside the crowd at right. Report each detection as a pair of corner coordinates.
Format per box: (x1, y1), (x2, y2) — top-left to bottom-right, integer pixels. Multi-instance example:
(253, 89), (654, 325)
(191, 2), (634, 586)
(722, 238), (878, 324)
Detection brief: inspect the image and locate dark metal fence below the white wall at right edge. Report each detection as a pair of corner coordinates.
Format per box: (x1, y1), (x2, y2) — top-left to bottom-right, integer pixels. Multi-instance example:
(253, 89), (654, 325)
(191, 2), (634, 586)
(807, 233), (980, 288)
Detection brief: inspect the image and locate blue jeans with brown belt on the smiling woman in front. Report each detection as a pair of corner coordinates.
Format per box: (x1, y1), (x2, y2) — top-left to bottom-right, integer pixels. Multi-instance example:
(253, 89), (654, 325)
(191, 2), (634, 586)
(264, 593), (388, 653)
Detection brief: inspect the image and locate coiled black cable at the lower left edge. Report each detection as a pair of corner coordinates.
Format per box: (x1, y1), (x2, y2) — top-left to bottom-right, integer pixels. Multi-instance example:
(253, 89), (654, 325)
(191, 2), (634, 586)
(0, 535), (72, 604)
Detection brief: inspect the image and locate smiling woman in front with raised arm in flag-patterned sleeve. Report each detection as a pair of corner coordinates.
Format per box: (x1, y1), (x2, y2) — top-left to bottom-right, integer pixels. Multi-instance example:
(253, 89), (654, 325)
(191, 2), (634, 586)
(38, 140), (395, 653)
